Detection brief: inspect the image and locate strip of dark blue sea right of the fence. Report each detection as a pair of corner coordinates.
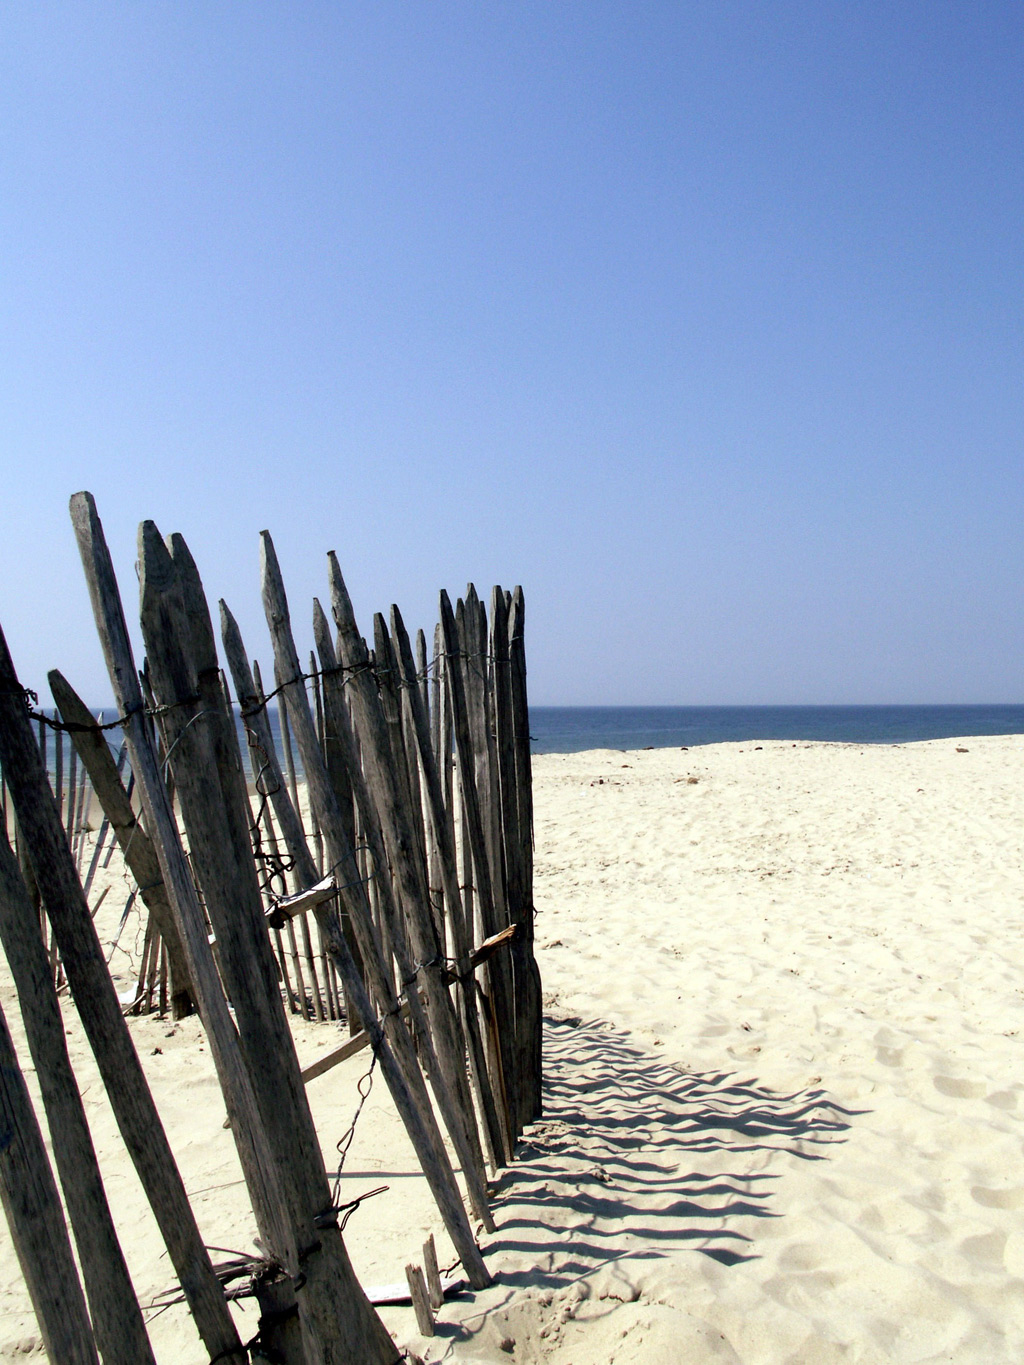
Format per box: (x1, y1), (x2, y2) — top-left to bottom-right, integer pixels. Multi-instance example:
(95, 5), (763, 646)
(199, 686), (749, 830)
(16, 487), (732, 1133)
(530, 706), (1024, 753)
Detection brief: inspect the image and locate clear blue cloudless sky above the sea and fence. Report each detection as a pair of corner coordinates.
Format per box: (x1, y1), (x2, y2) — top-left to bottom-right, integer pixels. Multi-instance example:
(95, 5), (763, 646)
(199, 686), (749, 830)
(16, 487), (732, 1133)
(0, 0), (1024, 704)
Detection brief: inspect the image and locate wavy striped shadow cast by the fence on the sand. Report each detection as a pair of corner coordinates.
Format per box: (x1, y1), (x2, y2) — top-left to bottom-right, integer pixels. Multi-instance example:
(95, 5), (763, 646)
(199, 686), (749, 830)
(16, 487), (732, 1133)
(489, 1018), (856, 1289)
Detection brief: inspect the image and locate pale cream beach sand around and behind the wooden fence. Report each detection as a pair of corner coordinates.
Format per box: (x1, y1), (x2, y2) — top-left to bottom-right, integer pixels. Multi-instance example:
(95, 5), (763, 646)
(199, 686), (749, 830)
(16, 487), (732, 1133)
(0, 737), (1024, 1365)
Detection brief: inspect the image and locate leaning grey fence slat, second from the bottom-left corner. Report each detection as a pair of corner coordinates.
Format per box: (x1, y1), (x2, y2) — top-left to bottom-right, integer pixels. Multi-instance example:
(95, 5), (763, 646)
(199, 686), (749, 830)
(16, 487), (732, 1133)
(0, 830), (153, 1365)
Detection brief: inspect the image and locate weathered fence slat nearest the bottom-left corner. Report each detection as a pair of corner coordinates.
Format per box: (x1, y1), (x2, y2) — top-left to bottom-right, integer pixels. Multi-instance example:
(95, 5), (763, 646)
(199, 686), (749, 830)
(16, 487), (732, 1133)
(0, 993), (98, 1365)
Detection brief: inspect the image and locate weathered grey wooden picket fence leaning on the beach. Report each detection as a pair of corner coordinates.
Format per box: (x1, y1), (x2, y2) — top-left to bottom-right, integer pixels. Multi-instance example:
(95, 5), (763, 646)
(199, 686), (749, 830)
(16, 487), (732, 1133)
(0, 493), (541, 1365)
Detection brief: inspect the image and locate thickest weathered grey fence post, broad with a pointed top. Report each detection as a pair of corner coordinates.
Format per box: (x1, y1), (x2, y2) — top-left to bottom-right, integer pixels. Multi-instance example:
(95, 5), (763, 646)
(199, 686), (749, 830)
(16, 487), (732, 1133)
(139, 521), (393, 1365)
